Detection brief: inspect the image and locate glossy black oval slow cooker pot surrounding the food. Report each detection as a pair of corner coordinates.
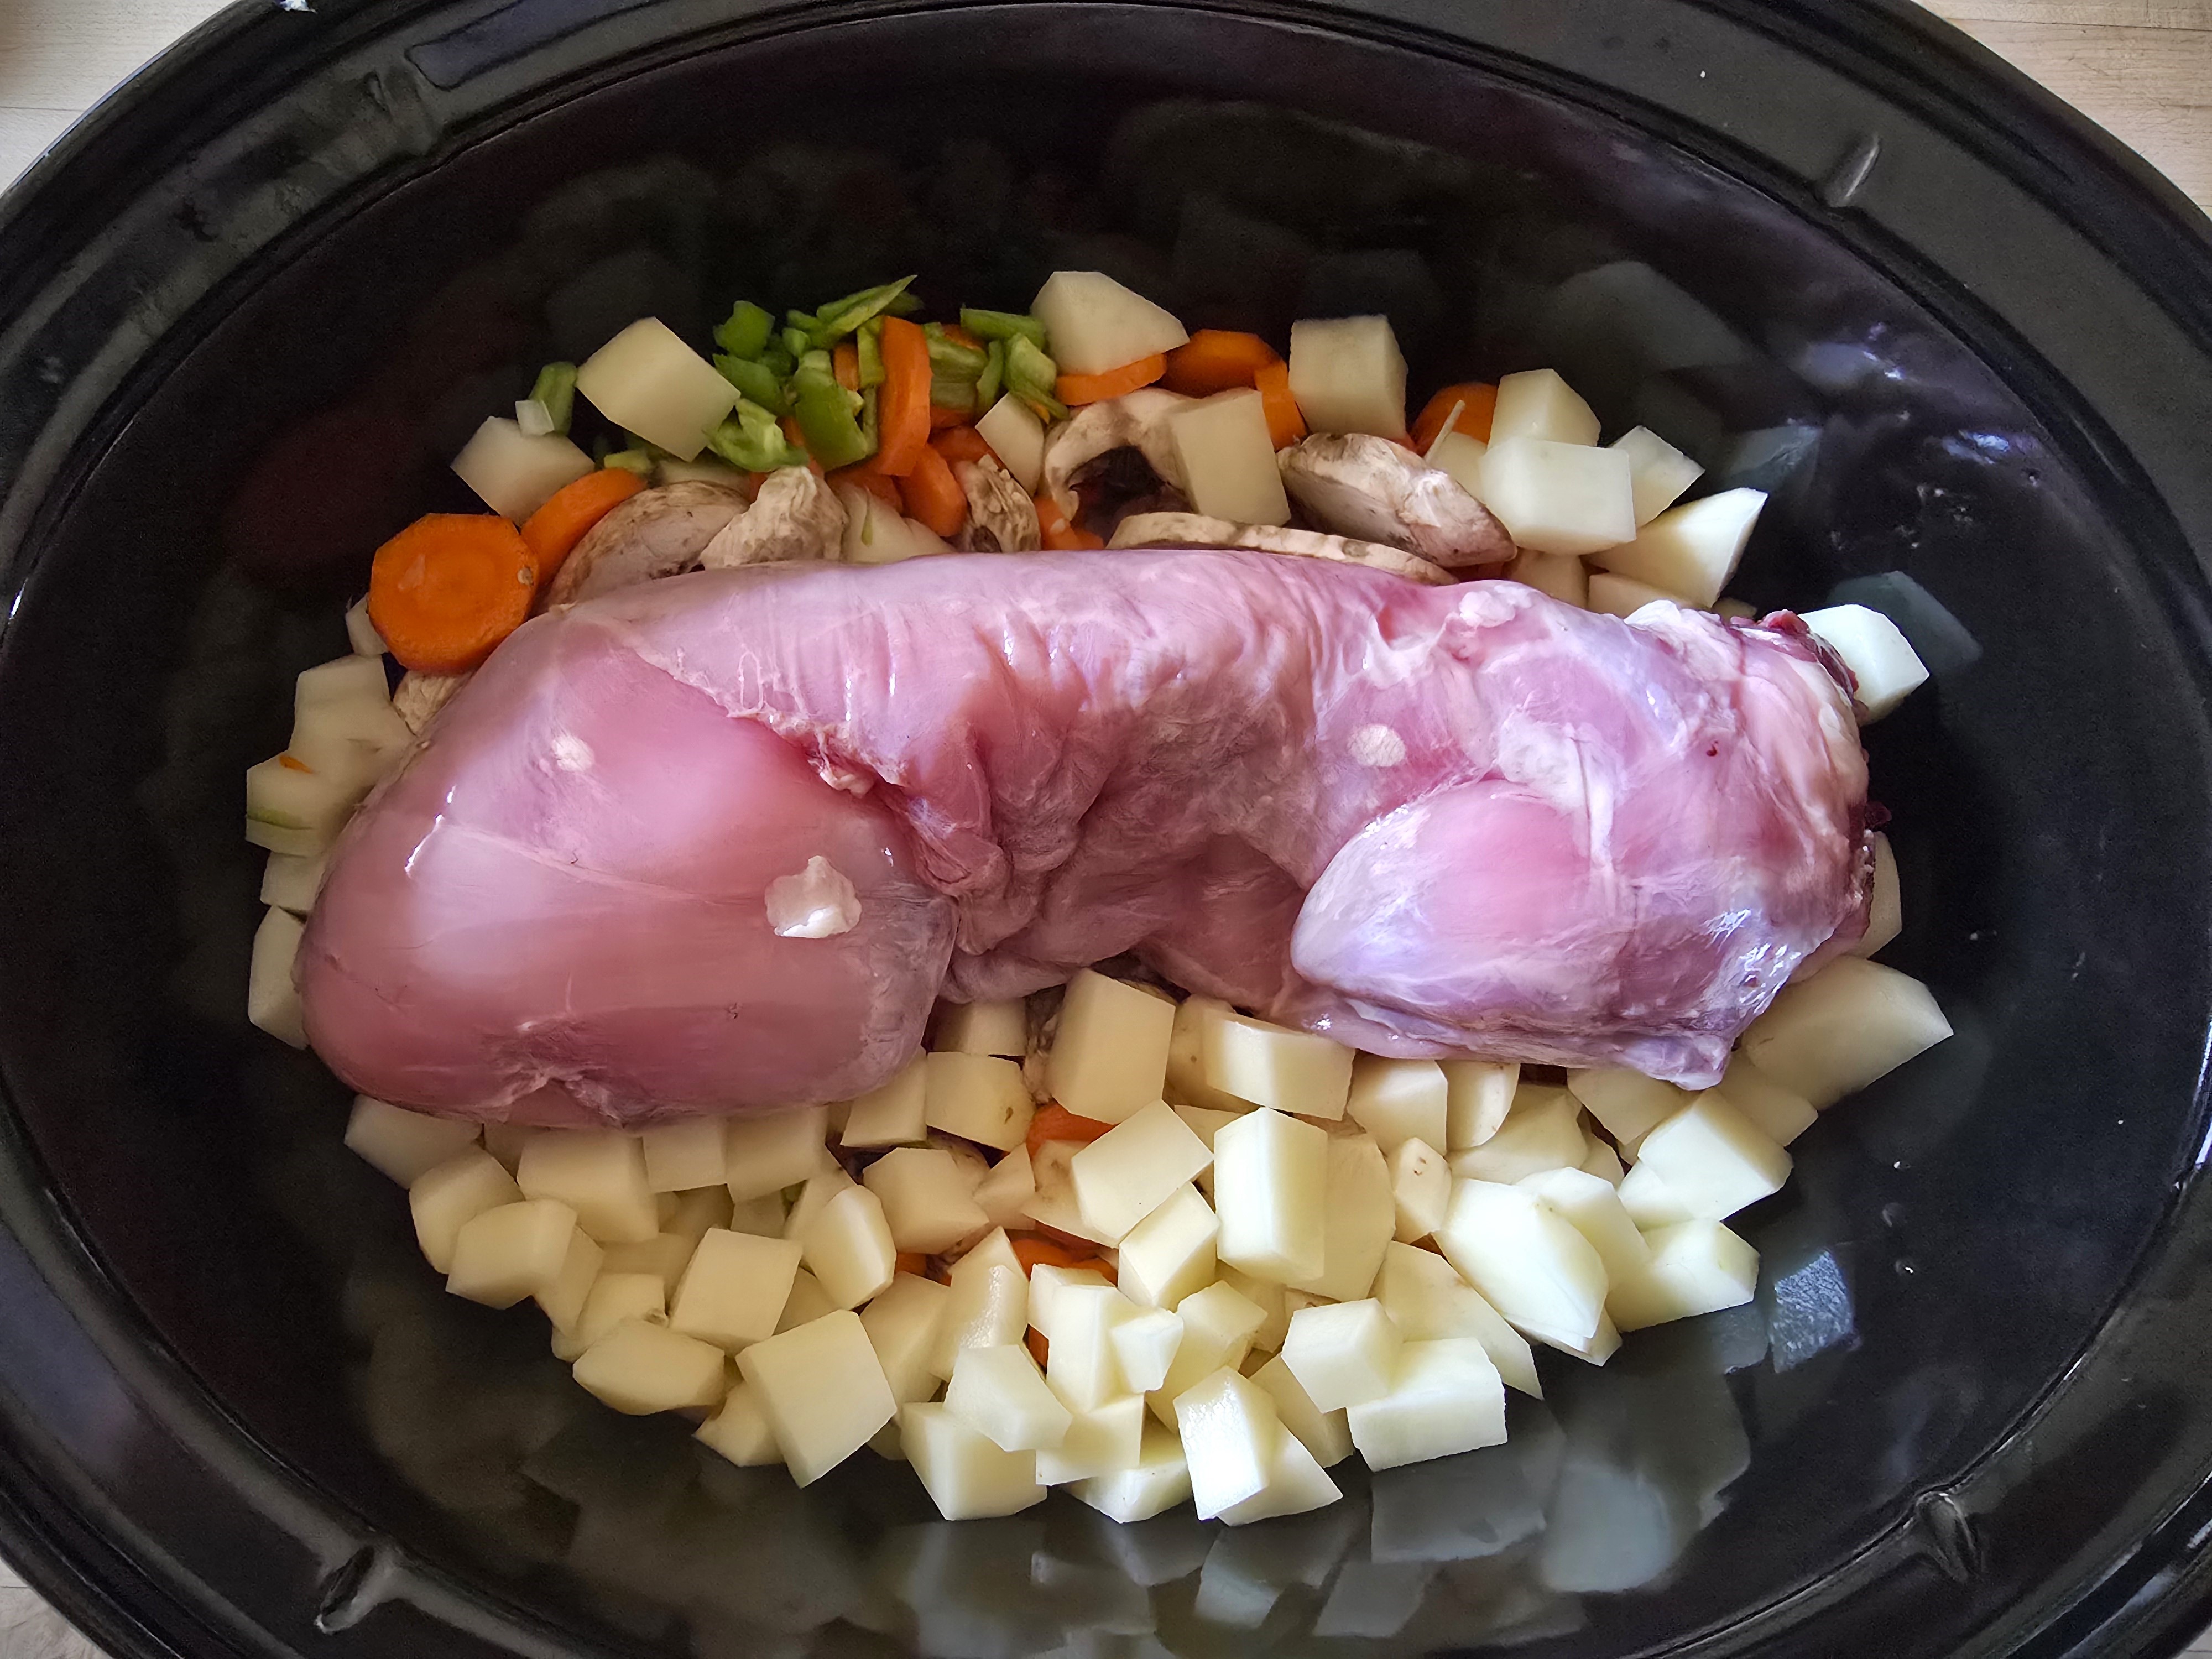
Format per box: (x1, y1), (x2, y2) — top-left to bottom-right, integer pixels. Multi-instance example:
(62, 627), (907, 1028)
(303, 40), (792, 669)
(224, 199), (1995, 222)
(0, 0), (2212, 1657)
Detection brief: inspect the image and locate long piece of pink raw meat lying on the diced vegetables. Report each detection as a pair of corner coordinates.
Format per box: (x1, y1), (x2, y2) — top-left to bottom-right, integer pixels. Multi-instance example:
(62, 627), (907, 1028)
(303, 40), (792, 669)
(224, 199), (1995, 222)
(299, 551), (1871, 1124)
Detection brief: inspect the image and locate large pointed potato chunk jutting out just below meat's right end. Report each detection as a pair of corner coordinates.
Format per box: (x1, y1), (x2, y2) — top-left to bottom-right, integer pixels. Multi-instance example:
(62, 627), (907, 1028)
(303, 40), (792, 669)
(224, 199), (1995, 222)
(1743, 956), (1951, 1110)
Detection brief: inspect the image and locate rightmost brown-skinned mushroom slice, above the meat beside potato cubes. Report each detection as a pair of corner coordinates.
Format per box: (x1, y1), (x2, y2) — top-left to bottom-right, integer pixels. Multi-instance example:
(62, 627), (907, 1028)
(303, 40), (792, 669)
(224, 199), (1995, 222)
(1281, 431), (1515, 571)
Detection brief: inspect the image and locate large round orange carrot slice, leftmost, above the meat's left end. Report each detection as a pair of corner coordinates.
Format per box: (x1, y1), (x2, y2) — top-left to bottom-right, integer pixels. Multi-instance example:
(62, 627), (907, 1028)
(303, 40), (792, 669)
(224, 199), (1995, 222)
(369, 513), (538, 675)
